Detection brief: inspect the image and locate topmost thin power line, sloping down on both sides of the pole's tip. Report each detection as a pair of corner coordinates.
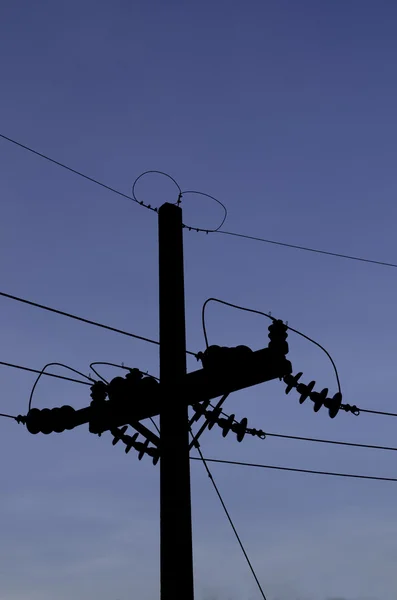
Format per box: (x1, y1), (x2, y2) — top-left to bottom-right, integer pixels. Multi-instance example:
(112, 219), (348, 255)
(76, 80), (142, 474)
(0, 133), (397, 269)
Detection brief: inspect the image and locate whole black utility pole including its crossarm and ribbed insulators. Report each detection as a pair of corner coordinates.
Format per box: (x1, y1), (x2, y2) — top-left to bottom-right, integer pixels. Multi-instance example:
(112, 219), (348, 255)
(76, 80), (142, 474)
(21, 203), (330, 600)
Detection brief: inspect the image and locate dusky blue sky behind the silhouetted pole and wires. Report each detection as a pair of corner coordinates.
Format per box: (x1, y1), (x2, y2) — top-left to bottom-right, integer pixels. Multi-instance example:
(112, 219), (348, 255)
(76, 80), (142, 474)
(0, 0), (397, 600)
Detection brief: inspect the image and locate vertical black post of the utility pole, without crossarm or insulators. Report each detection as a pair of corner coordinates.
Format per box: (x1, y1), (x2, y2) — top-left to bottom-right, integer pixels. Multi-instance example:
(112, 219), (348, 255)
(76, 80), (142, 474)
(158, 203), (194, 600)
